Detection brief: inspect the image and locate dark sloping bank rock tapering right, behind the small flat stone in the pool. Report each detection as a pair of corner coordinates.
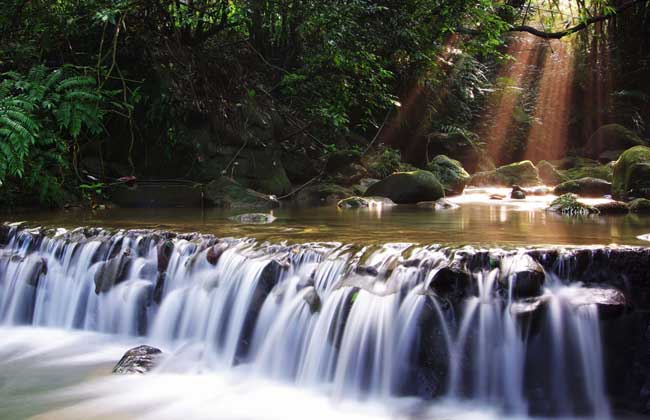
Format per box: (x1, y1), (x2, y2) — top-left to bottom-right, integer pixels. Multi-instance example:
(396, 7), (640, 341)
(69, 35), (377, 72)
(205, 176), (280, 209)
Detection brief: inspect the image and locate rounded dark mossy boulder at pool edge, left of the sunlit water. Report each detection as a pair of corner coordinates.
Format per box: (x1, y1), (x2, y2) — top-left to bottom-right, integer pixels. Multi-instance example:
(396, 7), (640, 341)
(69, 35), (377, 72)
(364, 170), (445, 204)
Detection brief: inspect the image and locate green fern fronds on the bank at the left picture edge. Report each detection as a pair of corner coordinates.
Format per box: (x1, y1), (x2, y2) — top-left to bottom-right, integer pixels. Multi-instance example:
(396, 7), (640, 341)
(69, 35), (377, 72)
(0, 65), (104, 203)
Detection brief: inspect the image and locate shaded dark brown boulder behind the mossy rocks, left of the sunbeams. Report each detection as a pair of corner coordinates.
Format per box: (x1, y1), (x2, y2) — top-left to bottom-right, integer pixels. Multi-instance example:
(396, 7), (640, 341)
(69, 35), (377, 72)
(427, 133), (484, 173)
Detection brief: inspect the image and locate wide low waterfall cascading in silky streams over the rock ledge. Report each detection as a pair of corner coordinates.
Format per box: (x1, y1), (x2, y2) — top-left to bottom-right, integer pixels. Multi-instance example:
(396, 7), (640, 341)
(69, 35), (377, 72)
(0, 226), (614, 418)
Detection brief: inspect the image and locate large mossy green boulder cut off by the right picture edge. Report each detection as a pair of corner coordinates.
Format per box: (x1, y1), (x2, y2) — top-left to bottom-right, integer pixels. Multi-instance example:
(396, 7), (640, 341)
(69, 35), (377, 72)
(612, 146), (650, 200)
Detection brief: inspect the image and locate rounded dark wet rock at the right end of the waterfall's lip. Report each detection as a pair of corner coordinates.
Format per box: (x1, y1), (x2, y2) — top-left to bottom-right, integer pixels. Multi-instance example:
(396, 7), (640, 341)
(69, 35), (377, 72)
(499, 254), (546, 298)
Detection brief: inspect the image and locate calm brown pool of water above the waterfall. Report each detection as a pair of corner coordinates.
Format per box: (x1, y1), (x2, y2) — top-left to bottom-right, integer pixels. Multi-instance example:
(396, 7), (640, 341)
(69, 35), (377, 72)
(3, 190), (650, 246)
